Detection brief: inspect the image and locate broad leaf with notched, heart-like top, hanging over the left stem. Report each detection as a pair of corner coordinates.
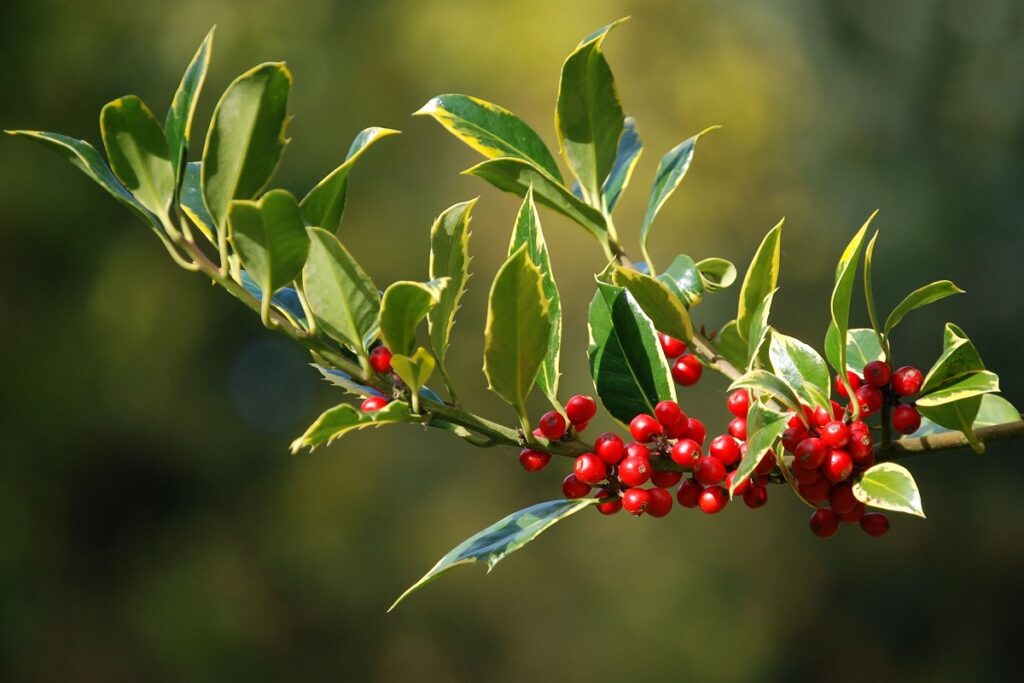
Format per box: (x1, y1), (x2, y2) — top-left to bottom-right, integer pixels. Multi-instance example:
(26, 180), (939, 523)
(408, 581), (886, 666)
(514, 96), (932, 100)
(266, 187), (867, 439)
(227, 189), (309, 324)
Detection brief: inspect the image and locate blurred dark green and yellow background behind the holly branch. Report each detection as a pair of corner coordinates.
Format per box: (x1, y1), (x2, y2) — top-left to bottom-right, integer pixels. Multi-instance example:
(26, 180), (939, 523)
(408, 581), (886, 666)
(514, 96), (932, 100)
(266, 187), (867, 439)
(0, 0), (1024, 682)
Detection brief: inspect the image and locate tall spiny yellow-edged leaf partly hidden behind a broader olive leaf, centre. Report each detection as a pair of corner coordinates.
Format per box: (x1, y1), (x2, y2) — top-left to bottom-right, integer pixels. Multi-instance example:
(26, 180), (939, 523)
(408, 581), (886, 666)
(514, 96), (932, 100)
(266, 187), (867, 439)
(509, 189), (562, 410)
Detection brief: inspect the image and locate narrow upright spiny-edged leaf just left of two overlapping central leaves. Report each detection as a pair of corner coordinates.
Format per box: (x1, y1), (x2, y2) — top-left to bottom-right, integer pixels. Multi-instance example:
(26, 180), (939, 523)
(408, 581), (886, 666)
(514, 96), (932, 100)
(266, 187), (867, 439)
(428, 200), (476, 369)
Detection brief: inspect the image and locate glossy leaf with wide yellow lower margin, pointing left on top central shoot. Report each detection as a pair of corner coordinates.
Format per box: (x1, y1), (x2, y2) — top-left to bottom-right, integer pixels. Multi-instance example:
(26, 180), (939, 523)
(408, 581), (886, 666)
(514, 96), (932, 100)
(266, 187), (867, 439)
(413, 94), (562, 183)
